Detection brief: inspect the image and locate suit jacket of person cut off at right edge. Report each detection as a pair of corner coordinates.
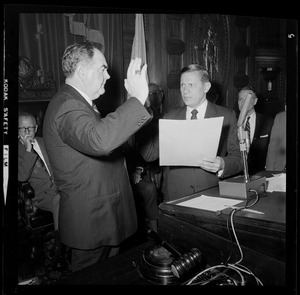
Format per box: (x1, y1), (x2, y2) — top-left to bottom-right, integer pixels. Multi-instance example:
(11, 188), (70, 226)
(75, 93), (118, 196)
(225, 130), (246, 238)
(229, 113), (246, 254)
(266, 111), (286, 171)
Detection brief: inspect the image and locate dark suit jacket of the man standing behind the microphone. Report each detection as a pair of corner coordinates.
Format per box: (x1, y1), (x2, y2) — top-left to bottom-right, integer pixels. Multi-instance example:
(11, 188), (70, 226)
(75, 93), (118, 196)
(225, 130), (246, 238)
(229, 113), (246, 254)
(248, 112), (273, 175)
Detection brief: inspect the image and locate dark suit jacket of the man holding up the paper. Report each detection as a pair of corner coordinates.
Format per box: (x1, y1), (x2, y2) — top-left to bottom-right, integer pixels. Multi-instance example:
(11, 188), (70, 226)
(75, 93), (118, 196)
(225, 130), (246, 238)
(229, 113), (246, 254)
(141, 101), (243, 201)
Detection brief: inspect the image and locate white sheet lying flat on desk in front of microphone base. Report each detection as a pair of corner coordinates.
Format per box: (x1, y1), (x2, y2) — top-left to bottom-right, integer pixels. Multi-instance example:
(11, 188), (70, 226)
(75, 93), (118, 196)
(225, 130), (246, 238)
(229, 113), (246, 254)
(176, 195), (243, 212)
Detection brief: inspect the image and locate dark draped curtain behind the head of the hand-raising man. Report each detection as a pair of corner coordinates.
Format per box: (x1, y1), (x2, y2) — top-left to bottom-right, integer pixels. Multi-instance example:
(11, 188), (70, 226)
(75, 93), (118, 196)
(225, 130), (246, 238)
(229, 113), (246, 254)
(19, 13), (125, 113)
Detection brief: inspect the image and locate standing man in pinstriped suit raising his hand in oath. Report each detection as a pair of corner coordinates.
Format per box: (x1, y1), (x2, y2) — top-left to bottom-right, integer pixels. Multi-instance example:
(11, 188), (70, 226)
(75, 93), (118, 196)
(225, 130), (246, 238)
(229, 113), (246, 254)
(43, 42), (151, 271)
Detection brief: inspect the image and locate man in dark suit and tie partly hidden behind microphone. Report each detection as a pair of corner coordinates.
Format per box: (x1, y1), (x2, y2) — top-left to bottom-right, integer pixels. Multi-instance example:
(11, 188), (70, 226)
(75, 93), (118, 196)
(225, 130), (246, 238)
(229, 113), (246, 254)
(238, 86), (273, 175)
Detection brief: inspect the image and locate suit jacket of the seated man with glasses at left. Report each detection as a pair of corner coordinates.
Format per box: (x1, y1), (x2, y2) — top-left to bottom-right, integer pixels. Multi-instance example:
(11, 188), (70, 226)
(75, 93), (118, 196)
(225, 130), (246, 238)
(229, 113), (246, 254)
(18, 137), (57, 211)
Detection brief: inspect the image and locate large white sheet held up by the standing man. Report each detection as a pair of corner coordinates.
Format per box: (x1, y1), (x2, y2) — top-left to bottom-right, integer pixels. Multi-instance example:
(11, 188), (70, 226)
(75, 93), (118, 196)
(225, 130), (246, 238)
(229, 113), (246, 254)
(159, 117), (224, 166)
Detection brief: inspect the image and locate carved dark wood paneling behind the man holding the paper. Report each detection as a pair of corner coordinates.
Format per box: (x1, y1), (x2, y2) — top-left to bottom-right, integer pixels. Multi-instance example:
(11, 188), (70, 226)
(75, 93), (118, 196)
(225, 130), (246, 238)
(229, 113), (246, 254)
(123, 14), (286, 116)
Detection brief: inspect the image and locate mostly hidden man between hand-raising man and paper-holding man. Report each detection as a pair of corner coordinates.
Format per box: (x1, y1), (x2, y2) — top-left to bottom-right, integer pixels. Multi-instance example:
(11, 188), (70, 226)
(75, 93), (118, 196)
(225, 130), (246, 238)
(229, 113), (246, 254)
(127, 83), (164, 231)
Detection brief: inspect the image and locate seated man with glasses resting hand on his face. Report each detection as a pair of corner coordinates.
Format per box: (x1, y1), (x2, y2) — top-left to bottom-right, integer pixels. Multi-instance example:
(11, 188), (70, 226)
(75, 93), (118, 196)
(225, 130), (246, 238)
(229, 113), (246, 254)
(18, 112), (65, 267)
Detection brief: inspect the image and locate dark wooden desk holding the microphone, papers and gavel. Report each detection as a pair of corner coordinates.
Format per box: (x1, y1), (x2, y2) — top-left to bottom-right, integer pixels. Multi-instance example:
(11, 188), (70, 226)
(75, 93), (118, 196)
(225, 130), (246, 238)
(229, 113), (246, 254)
(57, 171), (285, 286)
